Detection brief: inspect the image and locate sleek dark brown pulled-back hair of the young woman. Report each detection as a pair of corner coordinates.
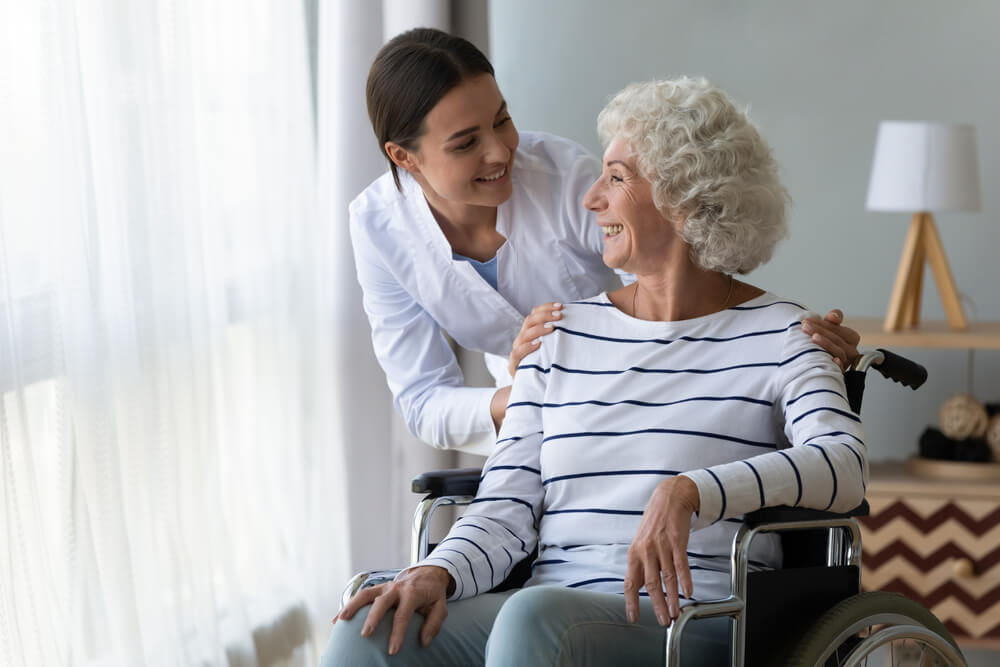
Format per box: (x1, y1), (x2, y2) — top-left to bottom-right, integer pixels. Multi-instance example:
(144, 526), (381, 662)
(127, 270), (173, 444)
(366, 28), (493, 189)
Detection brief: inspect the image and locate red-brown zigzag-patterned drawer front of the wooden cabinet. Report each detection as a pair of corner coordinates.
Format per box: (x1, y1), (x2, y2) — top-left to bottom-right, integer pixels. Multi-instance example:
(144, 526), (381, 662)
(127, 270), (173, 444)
(859, 497), (1000, 639)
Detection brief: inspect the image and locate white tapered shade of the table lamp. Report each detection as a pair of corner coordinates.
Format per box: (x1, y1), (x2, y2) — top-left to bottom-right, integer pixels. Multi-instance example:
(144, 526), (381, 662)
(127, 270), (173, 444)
(865, 121), (980, 212)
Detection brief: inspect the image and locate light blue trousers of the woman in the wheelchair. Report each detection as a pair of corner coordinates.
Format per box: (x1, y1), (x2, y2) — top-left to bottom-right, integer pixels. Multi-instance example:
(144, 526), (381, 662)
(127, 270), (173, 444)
(321, 586), (729, 667)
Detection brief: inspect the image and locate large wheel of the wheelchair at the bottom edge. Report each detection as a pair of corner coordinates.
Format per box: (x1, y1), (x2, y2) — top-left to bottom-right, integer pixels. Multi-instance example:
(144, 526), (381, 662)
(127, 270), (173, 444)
(787, 592), (965, 667)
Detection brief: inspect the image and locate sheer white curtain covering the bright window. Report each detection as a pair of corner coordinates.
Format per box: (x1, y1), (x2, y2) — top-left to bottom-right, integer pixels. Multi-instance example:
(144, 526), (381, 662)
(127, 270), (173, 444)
(0, 0), (352, 667)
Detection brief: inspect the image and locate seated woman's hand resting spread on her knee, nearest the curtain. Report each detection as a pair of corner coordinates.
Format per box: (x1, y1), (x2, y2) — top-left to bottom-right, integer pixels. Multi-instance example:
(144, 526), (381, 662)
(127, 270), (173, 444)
(333, 565), (455, 655)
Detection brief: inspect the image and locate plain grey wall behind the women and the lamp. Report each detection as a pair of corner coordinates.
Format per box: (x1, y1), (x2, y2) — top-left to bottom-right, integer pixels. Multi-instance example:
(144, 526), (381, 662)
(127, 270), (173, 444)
(490, 0), (1000, 468)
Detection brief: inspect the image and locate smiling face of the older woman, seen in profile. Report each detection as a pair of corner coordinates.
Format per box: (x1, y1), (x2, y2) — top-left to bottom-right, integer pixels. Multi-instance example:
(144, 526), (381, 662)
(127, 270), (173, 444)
(583, 139), (682, 274)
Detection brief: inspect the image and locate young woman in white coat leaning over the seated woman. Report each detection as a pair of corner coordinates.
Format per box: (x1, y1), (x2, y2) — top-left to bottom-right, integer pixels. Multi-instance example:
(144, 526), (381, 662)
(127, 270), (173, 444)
(350, 29), (859, 454)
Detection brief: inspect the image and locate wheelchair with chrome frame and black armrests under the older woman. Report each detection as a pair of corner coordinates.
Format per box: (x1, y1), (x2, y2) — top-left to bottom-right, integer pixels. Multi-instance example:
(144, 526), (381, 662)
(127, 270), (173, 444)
(341, 349), (966, 667)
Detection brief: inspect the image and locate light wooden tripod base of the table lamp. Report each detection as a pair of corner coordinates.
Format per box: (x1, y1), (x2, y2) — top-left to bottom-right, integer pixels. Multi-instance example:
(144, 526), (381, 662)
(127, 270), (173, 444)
(882, 212), (969, 331)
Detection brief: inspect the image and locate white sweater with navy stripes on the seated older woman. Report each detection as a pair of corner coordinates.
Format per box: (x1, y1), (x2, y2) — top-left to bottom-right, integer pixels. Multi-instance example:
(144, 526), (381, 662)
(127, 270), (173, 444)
(421, 294), (868, 599)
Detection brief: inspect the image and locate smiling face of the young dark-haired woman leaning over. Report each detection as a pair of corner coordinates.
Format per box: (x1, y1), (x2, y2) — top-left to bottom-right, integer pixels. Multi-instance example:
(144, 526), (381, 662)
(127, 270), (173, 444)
(386, 74), (519, 222)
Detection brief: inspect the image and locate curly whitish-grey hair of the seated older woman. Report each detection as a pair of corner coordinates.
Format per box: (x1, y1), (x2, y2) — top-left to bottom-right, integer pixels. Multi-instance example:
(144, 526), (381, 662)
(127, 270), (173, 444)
(597, 77), (790, 274)
